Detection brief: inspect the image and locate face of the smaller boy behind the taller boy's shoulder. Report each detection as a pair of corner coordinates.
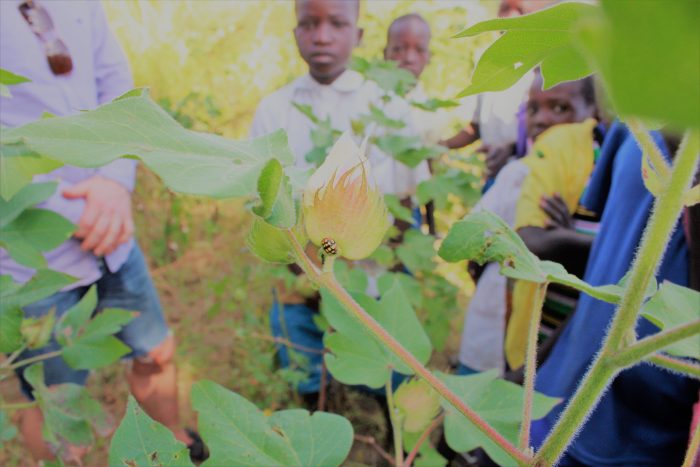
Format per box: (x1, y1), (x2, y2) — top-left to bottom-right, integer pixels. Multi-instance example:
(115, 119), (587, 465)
(384, 19), (430, 78)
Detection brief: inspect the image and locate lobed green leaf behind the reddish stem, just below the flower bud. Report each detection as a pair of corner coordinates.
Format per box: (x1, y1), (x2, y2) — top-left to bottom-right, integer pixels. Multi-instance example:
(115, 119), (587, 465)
(321, 282), (432, 388)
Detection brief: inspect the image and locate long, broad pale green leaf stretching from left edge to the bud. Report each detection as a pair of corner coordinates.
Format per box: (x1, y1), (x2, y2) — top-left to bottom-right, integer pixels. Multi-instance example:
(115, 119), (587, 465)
(1, 93), (294, 198)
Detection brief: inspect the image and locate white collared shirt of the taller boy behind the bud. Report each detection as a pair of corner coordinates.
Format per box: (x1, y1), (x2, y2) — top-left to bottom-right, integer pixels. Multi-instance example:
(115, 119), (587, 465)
(250, 70), (429, 197)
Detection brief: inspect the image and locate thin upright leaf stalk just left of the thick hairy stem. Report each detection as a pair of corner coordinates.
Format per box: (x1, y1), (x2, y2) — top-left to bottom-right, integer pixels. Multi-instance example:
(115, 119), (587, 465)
(518, 282), (548, 451)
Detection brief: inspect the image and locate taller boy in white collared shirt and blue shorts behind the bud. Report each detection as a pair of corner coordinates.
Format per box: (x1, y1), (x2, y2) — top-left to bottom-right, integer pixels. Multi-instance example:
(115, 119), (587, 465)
(251, 0), (430, 404)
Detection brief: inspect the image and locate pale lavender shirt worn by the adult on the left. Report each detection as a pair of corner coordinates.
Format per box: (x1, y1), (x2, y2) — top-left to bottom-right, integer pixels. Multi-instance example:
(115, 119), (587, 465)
(0, 0), (136, 288)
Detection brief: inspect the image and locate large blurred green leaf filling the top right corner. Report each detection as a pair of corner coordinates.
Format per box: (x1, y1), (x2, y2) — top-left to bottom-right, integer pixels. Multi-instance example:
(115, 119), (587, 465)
(576, 0), (700, 128)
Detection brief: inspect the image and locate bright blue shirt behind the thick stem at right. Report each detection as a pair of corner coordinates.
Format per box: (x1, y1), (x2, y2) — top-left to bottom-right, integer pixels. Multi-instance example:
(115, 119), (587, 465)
(532, 124), (700, 465)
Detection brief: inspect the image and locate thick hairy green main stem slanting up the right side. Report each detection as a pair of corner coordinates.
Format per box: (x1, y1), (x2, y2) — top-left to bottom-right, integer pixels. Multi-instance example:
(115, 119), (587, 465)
(535, 131), (700, 465)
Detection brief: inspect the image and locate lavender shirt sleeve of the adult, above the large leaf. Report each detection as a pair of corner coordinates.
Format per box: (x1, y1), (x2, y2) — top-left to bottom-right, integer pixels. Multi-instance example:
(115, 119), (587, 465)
(91, 2), (134, 105)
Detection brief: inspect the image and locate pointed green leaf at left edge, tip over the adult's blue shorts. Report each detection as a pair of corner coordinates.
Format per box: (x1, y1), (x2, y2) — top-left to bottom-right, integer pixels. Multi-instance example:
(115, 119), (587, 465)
(0, 269), (76, 310)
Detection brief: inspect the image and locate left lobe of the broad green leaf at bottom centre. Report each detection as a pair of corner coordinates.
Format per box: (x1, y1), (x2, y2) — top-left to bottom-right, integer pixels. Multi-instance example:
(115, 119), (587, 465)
(192, 381), (299, 466)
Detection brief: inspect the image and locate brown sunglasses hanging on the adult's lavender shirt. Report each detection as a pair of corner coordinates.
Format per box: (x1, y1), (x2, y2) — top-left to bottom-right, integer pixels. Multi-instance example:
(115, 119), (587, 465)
(19, 0), (73, 75)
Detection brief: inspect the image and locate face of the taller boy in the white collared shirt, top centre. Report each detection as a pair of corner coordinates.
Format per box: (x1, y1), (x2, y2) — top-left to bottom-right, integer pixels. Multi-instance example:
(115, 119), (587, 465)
(294, 0), (362, 84)
